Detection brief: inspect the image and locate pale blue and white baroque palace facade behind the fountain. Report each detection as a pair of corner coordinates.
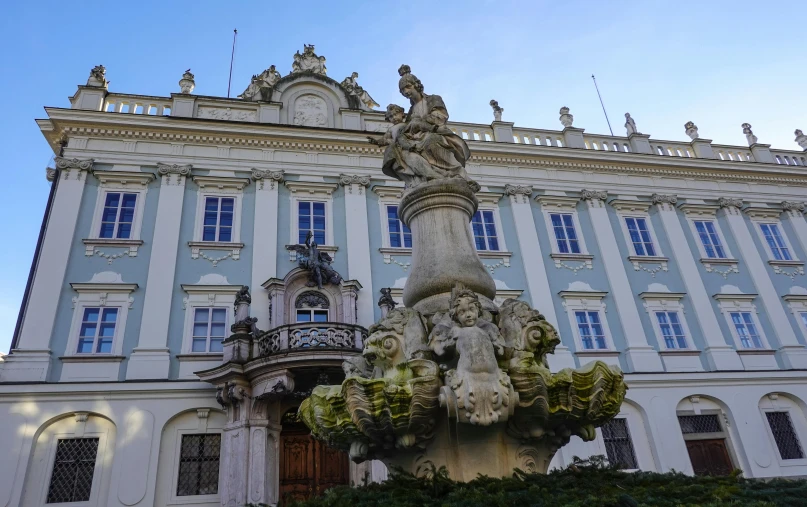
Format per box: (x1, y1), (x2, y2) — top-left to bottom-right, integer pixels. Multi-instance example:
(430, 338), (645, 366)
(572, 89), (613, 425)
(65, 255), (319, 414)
(0, 46), (807, 507)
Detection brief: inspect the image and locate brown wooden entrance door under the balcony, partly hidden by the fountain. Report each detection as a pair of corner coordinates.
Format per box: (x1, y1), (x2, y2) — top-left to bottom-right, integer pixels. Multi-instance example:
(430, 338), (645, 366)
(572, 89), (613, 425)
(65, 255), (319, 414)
(279, 407), (350, 505)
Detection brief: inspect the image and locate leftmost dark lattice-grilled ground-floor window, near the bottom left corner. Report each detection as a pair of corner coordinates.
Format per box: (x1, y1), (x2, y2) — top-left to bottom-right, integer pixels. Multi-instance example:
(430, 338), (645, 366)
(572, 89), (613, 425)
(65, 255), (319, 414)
(47, 438), (98, 503)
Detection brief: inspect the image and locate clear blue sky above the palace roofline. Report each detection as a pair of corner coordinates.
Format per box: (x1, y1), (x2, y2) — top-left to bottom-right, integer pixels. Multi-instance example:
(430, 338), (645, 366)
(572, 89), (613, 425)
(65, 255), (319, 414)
(0, 0), (807, 352)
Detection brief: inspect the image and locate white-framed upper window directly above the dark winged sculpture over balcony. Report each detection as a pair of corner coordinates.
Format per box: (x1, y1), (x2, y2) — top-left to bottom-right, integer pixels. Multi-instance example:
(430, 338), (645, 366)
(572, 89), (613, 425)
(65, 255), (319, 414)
(285, 180), (336, 248)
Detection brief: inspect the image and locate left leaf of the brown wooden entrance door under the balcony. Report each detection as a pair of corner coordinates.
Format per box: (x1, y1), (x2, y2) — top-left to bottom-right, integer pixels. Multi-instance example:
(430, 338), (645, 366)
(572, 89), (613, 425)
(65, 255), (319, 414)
(280, 433), (316, 503)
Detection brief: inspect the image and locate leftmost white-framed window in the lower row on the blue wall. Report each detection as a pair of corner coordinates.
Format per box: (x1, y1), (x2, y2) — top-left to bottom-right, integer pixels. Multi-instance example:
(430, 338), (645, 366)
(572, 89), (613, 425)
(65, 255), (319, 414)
(65, 272), (137, 358)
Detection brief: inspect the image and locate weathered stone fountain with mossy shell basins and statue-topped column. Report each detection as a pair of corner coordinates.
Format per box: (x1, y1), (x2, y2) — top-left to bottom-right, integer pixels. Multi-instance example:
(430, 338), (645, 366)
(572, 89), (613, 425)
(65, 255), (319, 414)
(299, 65), (627, 481)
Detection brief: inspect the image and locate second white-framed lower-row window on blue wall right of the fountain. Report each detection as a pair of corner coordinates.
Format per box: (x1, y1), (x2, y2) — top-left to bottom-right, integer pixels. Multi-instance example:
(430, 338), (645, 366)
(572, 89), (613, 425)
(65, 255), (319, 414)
(639, 292), (692, 350)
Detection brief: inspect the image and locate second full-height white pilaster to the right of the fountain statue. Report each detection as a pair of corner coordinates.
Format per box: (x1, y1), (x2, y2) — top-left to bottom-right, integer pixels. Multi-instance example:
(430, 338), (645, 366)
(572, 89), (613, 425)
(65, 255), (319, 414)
(581, 190), (664, 372)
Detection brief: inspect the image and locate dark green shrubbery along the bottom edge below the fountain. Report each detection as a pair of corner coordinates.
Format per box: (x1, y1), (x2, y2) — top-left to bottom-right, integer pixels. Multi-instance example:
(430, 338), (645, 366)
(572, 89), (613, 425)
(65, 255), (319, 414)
(284, 458), (807, 507)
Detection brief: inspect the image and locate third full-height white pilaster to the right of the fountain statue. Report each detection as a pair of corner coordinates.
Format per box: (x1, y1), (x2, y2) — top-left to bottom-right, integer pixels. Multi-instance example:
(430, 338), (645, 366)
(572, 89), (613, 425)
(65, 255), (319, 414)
(651, 194), (743, 370)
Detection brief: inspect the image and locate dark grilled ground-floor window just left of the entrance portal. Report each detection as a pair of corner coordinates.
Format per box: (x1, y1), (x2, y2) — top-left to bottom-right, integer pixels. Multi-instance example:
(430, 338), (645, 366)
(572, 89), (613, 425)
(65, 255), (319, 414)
(177, 433), (221, 496)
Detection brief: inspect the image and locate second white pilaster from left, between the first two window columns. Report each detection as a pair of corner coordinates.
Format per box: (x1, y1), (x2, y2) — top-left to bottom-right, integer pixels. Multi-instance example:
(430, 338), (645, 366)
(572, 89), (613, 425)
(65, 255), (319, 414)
(126, 164), (191, 380)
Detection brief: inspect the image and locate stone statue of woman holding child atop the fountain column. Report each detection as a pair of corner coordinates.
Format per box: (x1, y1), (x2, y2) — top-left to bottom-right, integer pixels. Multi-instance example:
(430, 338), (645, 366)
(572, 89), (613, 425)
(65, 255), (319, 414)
(370, 65), (471, 187)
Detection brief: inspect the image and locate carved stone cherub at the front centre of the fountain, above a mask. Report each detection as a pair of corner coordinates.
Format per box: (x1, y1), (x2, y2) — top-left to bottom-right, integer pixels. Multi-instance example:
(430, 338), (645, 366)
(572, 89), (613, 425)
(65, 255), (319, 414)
(429, 284), (512, 426)
